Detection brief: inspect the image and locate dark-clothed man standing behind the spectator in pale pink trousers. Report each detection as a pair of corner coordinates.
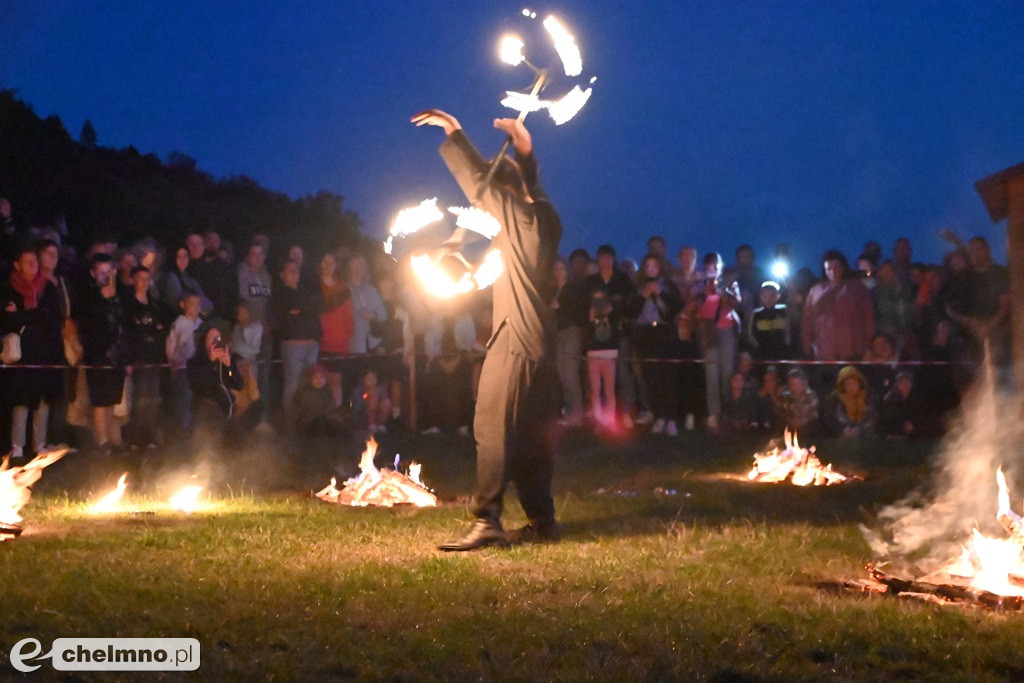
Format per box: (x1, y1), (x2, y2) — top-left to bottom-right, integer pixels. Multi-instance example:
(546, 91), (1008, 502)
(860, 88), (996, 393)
(587, 245), (637, 428)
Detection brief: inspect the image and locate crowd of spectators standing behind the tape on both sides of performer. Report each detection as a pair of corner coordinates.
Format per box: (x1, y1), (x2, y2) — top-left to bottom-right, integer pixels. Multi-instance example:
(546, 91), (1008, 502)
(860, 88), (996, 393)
(0, 192), (1010, 458)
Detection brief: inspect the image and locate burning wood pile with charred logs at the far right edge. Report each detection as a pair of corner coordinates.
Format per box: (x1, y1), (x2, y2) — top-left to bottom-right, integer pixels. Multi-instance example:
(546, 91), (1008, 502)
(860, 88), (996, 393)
(847, 468), (1024, 611)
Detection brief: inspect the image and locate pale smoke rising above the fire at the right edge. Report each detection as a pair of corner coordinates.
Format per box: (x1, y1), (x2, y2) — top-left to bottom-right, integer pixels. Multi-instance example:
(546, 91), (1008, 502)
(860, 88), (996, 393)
(861, 358), (1024, 572)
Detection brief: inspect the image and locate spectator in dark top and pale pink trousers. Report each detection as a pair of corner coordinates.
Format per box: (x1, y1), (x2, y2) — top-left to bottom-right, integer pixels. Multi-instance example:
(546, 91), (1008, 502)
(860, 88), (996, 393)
(587, 290), (621, 429)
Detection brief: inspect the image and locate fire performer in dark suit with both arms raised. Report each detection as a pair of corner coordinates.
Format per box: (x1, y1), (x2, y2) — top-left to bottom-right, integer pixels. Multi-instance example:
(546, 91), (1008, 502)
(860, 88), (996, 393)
(412, 110), (562, 551)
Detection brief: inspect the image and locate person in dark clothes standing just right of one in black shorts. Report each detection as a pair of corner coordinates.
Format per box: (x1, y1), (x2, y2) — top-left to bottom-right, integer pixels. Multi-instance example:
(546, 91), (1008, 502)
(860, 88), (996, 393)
(124, 265), (167, 449)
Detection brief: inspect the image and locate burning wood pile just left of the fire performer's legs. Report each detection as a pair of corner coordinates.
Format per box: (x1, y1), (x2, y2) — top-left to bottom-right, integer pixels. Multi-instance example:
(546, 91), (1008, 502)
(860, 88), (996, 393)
(316, 438), (437, 508)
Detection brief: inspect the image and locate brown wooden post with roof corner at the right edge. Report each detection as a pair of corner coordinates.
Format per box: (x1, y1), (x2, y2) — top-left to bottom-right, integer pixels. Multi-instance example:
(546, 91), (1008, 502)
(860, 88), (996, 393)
(974, 164), (1024, 391)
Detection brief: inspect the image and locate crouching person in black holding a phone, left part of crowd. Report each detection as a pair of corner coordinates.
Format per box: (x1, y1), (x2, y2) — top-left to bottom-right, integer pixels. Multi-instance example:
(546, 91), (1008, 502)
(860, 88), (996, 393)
(187, 326), (263, 449)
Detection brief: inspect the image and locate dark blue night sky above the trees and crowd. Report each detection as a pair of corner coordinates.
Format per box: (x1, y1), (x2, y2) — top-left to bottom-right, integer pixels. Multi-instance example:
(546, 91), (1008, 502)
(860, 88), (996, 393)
(0, 0), (1024, 270)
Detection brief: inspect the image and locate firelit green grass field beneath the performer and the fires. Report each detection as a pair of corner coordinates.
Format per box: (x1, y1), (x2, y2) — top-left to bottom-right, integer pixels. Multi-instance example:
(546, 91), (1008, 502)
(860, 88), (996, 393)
(0, 435), (1024, 681)
